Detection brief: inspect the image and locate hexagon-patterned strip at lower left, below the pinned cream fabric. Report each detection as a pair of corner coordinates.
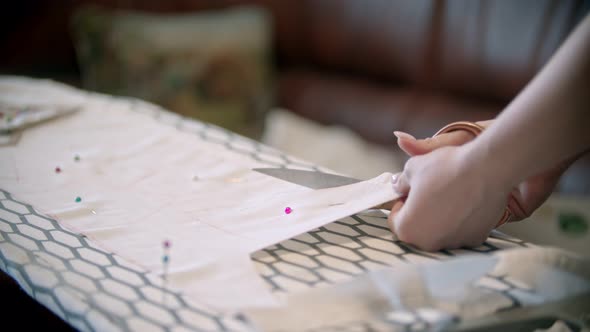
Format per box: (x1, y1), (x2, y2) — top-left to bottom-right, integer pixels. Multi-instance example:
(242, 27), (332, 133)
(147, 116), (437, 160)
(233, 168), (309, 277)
(0, 190), (243, 331)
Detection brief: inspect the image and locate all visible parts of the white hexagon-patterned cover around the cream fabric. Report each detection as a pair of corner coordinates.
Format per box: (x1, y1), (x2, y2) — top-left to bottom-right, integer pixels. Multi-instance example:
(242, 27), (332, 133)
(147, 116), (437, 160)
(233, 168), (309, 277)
(0, 92), (528, 331)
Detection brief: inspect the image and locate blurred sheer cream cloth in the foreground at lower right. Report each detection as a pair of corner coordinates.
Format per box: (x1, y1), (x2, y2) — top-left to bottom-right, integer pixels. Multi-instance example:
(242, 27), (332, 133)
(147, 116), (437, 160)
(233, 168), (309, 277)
(246, 247), (590, 332)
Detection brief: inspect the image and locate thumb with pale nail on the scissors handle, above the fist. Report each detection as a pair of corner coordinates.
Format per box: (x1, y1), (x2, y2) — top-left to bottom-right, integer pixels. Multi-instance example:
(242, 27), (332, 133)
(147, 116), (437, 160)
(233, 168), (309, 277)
(394, 130), (473, 156)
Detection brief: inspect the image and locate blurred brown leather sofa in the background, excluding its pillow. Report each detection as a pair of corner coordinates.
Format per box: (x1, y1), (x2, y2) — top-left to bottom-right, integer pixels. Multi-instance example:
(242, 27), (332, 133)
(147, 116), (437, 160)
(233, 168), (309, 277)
(0, 0), (590, 194)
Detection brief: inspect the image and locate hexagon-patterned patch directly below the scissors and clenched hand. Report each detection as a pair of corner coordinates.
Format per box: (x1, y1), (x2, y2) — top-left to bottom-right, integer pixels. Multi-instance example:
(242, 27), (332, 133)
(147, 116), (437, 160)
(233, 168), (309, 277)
(252, 212), (527, 304)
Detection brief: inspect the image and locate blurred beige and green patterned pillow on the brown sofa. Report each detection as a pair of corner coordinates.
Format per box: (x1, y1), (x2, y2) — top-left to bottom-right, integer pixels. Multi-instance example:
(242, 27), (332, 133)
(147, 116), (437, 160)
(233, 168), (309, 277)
(72, 7), (274, 138)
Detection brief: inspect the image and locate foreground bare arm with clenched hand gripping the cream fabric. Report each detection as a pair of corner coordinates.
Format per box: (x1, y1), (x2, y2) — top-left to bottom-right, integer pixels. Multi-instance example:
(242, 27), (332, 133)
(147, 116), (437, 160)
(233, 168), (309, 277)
(390, 15), (590, 250)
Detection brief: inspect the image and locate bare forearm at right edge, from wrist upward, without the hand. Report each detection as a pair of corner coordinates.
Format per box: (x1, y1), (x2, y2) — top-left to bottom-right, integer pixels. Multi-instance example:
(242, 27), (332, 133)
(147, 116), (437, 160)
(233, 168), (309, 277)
(466, 16), (590, 189)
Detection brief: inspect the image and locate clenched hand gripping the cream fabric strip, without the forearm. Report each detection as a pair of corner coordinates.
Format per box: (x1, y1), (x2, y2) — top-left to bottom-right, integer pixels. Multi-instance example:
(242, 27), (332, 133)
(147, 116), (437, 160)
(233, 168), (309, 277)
(388, 146), (511, 251)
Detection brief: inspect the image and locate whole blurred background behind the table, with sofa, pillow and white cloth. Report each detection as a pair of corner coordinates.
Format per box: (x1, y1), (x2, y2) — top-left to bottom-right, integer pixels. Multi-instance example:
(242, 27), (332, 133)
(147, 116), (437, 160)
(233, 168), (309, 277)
(0, 0), (590, 245)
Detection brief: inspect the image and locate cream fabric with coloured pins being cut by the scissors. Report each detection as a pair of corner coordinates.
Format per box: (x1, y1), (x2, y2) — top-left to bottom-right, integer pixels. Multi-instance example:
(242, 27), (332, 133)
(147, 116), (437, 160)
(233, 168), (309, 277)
(0, 78), (396, 309)
